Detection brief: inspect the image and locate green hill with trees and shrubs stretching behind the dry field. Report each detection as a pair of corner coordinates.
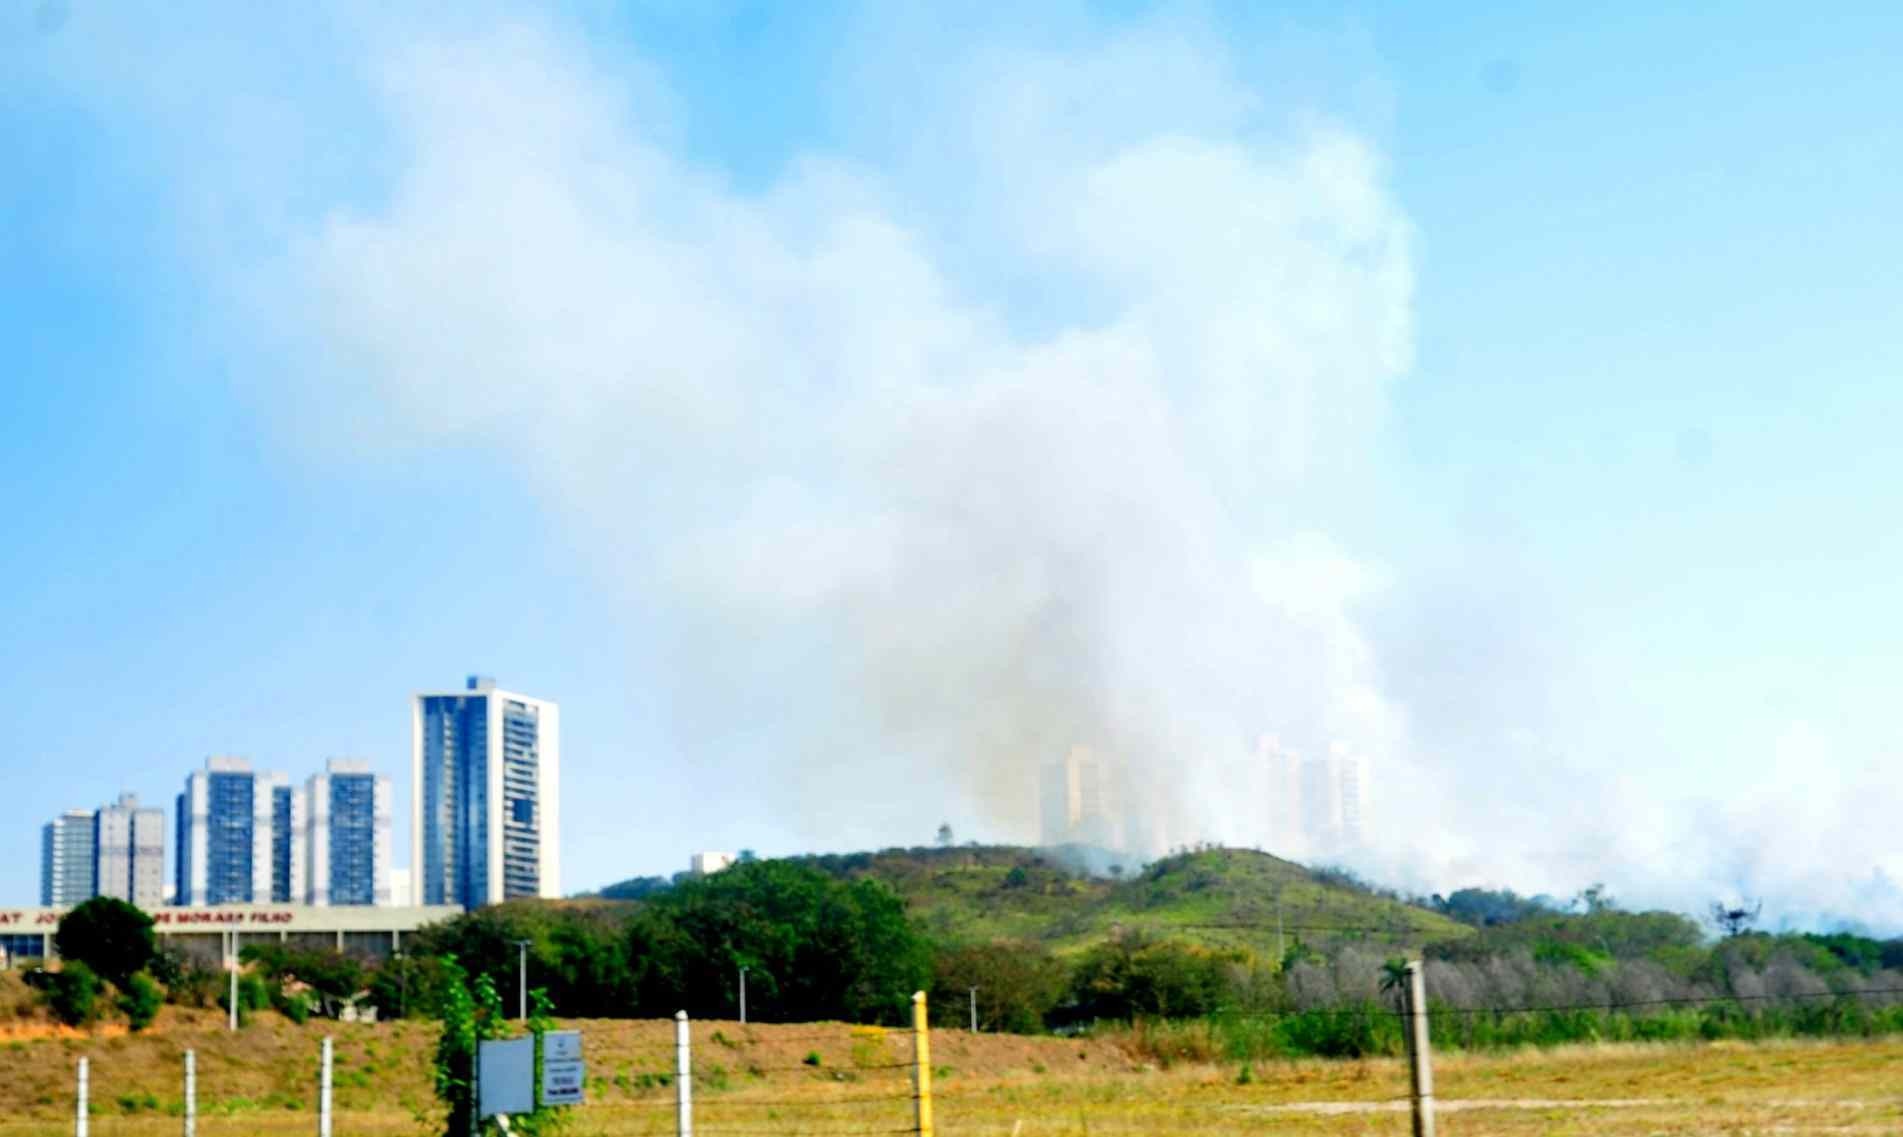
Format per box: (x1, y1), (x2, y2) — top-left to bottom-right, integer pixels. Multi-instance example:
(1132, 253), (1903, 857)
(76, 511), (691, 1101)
(18, 848), (1903, 1063)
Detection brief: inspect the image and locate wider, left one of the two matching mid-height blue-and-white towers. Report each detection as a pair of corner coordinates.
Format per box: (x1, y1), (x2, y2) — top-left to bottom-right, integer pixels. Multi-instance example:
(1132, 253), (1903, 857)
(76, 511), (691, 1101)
(173, 756), (304, 907)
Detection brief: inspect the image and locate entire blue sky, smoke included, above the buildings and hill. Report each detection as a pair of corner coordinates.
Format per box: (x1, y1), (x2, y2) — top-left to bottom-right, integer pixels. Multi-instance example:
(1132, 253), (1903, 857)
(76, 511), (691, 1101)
(0, 4), (1903, 928)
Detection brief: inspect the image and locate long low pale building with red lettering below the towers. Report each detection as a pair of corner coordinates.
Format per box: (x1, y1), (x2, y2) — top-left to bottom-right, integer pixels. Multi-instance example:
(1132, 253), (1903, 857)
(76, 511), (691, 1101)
(0, 905), (462, 964)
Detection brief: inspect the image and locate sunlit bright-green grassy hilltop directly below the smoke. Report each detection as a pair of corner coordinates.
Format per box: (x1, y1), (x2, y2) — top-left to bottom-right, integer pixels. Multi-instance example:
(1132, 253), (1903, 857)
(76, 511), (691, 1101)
(795, 848), (1471, 954)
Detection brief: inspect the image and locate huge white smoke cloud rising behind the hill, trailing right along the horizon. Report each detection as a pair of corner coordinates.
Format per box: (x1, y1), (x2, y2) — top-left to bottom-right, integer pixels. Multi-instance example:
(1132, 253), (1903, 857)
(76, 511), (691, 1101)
(29, 6), (1903, 926)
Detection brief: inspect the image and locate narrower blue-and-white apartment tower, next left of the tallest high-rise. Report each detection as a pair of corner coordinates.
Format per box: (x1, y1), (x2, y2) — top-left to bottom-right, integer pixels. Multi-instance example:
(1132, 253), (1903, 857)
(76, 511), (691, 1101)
(301, 758), (390, 908)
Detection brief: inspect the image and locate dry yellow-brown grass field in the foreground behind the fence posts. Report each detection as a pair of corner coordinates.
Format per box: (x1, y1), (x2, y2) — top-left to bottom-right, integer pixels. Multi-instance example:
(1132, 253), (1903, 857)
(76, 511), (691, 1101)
(0, 1009), (1903, 1137)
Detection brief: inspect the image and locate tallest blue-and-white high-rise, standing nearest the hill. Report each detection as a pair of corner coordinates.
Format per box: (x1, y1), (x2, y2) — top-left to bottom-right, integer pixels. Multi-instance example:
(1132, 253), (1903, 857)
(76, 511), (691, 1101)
(409, 676), (561, 908)
